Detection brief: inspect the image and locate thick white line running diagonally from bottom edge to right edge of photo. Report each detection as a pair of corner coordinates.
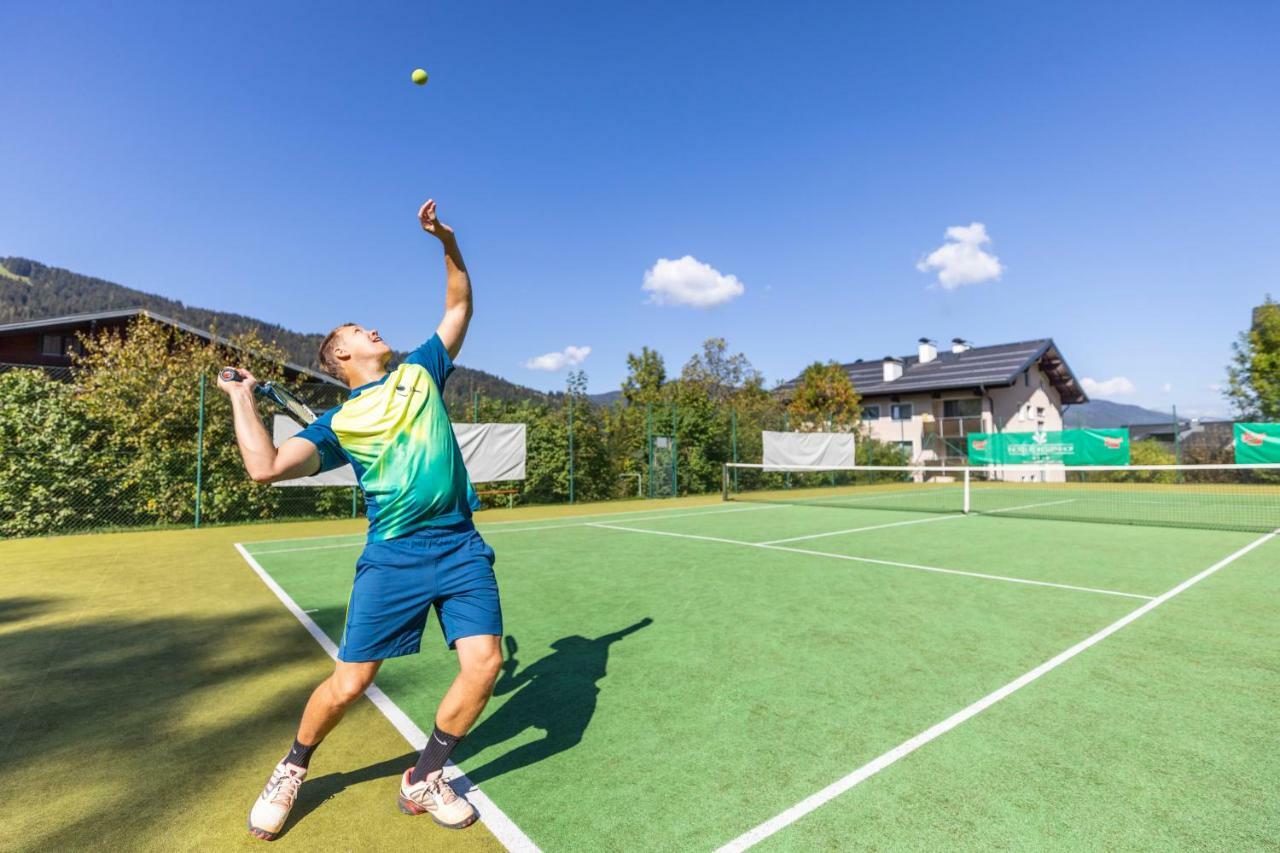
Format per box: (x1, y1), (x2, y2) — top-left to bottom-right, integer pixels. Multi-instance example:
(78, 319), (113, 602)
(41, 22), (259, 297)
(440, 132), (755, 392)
(716, 530), (1280, 853)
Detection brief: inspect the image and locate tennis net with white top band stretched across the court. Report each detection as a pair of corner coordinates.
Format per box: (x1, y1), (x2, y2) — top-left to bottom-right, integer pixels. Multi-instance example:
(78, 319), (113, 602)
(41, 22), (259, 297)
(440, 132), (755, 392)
(724, 462), (1280, 533)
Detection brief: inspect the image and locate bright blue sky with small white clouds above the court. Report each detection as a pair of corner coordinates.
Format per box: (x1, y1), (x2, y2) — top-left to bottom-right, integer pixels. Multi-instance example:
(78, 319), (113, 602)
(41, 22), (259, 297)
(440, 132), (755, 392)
(0, 1), (1280, 414)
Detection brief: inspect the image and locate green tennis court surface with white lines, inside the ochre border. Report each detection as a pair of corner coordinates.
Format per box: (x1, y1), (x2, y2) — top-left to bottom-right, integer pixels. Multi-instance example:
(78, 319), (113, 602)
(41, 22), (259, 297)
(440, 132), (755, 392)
(244, 502), (1280, 850)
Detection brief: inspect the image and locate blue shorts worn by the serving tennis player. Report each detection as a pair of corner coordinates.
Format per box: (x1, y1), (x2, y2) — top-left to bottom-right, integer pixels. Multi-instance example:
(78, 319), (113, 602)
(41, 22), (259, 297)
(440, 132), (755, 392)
(338, 521), (502, 662)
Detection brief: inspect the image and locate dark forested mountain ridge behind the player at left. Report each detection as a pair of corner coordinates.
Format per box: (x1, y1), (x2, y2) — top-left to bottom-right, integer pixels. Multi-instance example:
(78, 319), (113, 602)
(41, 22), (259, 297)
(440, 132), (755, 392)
(0, 257), (549, 402)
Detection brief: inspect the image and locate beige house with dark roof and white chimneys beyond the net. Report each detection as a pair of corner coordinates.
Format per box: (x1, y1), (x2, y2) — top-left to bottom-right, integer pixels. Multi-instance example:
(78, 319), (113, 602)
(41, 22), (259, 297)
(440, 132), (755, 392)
(782, 338), (1088, 465)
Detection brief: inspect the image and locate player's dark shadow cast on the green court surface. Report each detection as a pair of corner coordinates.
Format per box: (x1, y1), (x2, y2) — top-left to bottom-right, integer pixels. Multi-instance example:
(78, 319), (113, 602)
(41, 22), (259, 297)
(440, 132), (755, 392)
(453, 617), (653, 785)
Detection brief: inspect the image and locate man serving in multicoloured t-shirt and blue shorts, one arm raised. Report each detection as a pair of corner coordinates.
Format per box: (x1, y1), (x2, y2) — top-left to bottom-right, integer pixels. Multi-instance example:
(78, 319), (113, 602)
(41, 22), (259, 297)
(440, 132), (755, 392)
(218, 201), (502, 840)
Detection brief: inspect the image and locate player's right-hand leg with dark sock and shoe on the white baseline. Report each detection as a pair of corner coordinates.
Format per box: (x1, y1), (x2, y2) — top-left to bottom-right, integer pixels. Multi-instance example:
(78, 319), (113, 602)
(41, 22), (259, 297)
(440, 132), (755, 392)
(399, 635), (502, 829)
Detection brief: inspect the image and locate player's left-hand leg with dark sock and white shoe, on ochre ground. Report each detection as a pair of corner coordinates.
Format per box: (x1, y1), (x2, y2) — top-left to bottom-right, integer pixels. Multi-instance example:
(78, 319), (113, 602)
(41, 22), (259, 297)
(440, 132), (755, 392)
(248, 661), (381, 841)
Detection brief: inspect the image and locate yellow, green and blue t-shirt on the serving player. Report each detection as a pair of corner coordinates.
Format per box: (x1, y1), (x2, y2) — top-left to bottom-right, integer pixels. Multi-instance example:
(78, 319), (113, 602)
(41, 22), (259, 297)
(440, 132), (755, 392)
(298, 334), (479, 542)
